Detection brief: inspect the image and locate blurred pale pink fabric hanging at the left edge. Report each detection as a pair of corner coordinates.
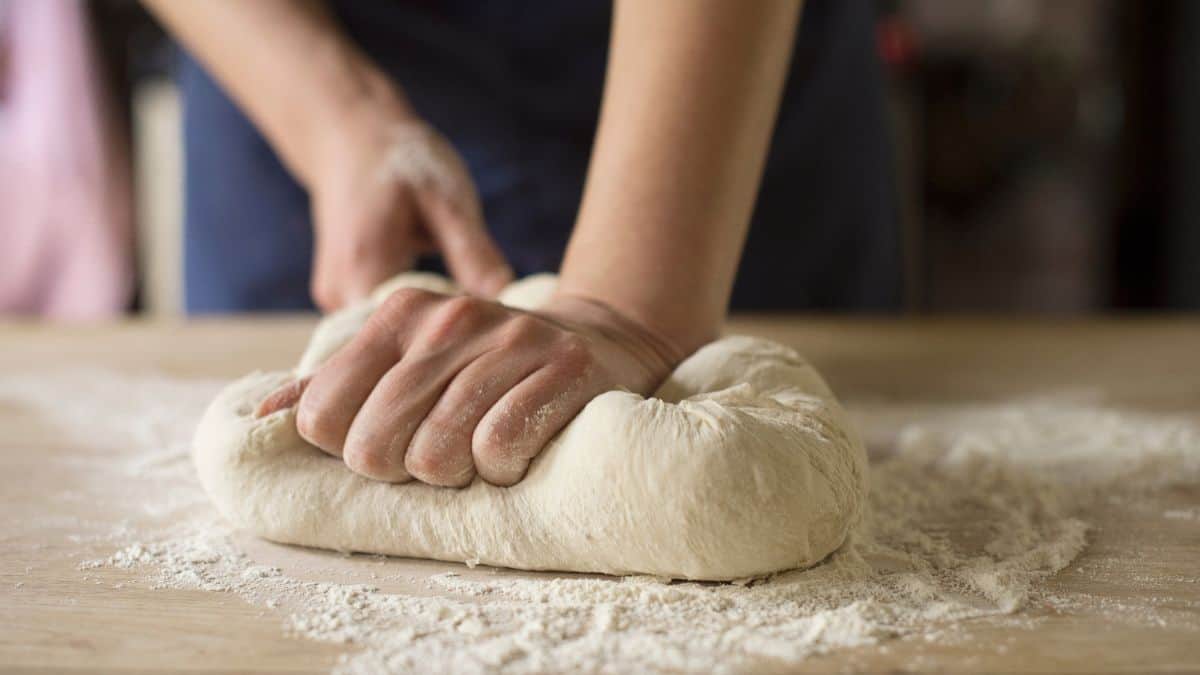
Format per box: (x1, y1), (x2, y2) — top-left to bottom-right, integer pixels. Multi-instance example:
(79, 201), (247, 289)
(0, 0), (133, 319)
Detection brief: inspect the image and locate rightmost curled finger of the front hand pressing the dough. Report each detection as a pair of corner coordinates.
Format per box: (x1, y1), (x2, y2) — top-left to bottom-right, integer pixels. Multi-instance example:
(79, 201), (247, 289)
(472, 338), (600, 485)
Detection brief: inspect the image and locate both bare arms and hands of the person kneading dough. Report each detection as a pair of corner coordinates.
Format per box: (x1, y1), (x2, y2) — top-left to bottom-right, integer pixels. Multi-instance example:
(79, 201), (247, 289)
(146, 0), (800, 486)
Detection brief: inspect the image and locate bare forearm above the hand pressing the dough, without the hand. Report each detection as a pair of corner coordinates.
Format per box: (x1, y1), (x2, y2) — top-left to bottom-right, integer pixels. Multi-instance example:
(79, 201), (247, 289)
(562, 0), (800, 353)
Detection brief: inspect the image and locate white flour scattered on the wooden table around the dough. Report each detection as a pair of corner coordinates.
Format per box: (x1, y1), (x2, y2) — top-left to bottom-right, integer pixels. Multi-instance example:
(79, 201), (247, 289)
(0, 374), (1200, 673)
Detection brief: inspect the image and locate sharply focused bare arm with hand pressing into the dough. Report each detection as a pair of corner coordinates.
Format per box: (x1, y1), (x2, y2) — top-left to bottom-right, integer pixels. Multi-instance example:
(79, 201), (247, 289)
(258, 0), (799, 486)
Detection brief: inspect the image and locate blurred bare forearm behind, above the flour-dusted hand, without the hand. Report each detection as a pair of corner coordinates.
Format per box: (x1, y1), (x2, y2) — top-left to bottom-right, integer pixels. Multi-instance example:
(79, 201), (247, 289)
(144, 0), (410, 185)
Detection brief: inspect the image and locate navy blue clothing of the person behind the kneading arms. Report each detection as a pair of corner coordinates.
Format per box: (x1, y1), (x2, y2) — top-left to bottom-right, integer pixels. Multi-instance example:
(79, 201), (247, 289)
(179, 0), (901, 312)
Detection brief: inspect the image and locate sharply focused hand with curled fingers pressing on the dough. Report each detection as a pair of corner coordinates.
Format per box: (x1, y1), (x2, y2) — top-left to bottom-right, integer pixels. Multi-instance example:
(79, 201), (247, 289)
(257, 288), (683, 486)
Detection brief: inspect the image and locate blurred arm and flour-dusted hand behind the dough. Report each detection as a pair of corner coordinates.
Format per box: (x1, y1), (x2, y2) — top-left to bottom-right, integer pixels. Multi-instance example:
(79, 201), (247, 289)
(144, 0), (511, 309)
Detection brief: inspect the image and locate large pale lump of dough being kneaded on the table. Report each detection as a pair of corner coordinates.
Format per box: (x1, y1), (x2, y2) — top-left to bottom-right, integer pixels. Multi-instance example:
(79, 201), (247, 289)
(194, 275), (866, 580)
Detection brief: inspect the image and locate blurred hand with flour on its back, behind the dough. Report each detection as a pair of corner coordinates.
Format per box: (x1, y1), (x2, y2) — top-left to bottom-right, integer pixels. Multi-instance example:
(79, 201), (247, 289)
(308, 106), (512, 311)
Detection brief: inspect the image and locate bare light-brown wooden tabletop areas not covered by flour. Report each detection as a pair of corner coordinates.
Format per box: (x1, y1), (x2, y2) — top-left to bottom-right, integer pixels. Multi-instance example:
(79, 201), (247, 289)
(0, 317), (1200, 671)
